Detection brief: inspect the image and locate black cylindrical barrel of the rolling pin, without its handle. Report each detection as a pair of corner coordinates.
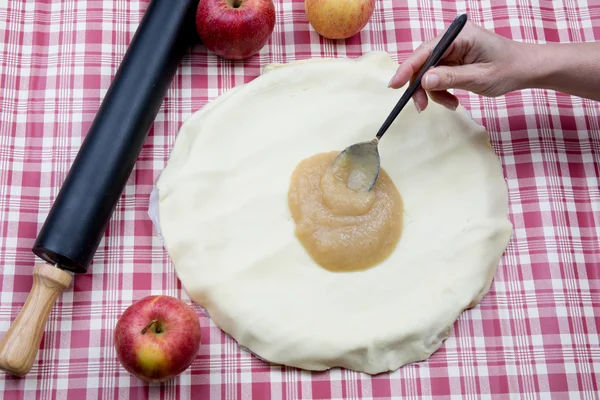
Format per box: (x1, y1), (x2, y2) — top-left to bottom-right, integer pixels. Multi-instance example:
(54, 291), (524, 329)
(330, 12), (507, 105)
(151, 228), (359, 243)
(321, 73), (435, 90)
(33, 0), (197, 273)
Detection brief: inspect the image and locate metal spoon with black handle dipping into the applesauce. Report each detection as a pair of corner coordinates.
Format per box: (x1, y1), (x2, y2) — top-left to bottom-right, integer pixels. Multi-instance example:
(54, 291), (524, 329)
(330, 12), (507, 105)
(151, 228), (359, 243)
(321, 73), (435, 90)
(331, 14), (467, 192)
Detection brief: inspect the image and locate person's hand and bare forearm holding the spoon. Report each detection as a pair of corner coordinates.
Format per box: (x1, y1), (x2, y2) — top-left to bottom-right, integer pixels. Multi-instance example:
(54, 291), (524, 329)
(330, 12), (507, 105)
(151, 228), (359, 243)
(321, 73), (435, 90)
(390, 22), (600, 111)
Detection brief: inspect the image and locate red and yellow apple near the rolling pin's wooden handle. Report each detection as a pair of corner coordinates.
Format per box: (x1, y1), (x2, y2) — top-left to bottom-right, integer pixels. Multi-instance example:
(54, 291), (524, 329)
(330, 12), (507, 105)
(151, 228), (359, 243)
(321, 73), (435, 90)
(114, 295), (201, 382)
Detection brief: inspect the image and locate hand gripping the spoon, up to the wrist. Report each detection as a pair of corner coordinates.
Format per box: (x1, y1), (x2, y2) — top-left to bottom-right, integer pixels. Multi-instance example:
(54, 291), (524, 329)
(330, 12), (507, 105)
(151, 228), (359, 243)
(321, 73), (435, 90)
(390, 21), (526, 111)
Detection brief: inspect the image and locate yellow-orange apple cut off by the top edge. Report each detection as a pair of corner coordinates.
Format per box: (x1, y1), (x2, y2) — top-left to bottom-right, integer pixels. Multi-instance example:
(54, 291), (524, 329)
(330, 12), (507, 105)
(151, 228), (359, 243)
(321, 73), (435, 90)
(304, 0), (375, 39)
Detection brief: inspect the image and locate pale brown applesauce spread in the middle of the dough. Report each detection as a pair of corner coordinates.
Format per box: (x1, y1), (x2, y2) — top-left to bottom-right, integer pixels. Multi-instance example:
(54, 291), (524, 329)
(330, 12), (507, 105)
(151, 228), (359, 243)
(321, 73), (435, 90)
(288, 152), (402, 272)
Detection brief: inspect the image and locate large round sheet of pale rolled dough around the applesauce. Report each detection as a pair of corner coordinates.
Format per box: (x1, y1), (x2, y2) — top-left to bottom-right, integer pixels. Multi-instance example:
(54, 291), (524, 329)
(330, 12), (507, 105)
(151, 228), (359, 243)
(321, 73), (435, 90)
(157, 52), (512, 374)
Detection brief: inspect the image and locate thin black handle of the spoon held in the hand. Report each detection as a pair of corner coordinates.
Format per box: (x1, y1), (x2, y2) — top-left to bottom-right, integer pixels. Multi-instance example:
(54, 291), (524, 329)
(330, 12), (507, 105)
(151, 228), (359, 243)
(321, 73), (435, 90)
(377, 14), (467, 139)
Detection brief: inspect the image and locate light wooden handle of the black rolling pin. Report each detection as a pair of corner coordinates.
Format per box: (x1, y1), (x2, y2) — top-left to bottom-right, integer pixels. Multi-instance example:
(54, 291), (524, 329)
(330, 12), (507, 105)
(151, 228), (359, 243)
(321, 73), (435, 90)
(0, 263), (73, 376)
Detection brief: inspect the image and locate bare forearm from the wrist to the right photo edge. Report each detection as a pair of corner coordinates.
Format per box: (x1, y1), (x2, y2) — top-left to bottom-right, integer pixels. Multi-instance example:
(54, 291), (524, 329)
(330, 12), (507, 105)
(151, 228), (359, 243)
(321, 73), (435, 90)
(521, 42), (600, 100)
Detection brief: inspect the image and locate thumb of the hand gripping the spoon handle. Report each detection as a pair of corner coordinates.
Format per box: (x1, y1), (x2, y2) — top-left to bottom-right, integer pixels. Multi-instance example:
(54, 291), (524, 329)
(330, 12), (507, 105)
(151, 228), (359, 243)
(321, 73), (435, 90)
(421, 64), (485, 92)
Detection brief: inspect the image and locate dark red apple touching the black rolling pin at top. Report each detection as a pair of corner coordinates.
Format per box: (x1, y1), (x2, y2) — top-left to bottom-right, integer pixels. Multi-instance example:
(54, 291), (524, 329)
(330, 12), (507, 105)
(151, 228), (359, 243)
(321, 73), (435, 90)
(196, 0), (275, 60)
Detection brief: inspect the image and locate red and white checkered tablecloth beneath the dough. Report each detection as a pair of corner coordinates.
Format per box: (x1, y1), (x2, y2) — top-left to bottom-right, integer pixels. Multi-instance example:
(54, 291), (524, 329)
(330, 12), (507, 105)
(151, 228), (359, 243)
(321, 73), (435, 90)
(0, 0), (600, 400)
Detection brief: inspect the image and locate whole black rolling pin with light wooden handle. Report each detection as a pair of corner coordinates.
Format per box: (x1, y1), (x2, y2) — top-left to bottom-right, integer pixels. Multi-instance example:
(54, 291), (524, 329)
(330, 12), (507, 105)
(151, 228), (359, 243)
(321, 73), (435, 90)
(0, 0), (199, 376)
